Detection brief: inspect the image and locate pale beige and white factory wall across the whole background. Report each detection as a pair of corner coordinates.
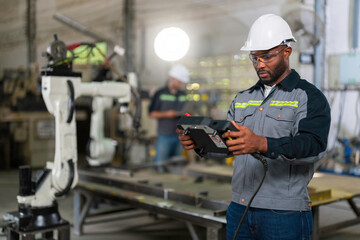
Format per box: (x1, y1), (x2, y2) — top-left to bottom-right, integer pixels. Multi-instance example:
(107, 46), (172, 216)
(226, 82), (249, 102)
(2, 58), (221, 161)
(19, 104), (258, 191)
(0, 0), (359, 145)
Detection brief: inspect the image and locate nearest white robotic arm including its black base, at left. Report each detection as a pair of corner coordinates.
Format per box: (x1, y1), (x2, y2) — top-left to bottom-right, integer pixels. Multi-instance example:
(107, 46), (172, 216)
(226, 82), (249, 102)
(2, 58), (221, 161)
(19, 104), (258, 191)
(13, 36), (131, 232)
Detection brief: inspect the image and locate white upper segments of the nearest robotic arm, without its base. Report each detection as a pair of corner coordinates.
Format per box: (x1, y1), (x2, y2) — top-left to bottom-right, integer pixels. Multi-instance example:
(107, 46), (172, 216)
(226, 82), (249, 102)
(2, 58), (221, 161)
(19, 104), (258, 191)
(42, 75), (131, 200)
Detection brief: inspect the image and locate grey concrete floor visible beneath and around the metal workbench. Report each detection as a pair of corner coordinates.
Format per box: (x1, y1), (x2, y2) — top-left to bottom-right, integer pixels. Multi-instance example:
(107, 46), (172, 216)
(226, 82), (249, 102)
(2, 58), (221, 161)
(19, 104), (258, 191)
(0, 170), (360, 240)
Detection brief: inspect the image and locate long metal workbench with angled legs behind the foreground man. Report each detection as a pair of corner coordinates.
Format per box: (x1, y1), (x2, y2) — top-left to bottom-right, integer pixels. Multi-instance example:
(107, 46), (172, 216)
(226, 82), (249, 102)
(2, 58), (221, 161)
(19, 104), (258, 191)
(74, 164), (360, 240)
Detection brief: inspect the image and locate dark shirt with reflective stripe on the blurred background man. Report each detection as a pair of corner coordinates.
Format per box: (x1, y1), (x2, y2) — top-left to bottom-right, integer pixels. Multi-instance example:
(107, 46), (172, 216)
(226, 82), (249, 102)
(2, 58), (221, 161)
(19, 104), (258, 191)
(149, 86), (186, 135)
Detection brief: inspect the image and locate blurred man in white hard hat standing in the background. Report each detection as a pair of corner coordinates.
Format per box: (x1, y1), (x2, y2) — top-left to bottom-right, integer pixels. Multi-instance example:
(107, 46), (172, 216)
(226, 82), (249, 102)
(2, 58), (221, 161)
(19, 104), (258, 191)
(149, 64), (189, 171)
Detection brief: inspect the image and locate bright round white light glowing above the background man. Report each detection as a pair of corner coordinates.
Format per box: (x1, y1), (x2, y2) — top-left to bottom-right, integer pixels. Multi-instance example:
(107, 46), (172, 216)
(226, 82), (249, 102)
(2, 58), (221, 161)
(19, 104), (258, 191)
(154, 27), (190, 62)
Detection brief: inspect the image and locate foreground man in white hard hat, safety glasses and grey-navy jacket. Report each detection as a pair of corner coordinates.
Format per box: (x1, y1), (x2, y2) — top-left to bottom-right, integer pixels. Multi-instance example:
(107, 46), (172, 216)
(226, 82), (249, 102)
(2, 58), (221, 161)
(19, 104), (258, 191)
(177, 14), (330, 240)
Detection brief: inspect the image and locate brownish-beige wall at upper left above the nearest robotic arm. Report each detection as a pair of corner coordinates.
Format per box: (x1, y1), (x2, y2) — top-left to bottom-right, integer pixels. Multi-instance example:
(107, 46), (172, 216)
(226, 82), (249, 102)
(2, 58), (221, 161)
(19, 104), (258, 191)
(0, 0), (123, 79)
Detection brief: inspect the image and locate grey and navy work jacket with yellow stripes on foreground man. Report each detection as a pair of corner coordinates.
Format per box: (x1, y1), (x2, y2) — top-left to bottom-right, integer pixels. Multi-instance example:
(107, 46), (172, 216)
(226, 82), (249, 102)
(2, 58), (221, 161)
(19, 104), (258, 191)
(227, 70), (330, 211)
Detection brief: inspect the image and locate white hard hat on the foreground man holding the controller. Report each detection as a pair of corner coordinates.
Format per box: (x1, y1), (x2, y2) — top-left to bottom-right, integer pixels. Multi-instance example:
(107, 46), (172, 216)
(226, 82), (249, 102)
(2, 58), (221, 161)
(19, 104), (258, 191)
(240, 14), (296, 51)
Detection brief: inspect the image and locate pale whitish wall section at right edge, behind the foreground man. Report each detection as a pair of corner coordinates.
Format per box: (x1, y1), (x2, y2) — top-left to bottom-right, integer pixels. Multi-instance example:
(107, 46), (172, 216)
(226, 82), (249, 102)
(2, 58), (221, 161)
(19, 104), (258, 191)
(324, 0), (360, 148)
